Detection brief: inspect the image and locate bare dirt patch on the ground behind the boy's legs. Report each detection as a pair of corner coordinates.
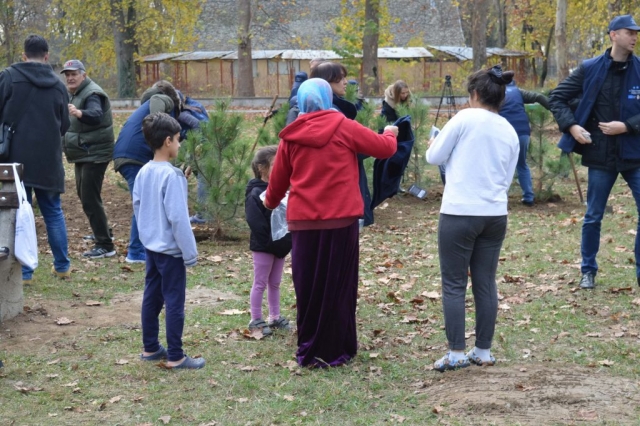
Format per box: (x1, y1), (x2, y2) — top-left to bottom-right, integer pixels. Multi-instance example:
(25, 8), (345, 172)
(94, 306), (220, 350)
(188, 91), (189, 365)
(0, 288), (238, 353)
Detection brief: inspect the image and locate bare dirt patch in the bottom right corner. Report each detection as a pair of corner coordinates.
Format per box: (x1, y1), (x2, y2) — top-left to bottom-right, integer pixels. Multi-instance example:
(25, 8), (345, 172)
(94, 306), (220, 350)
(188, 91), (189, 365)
(424, 365), (640, 425)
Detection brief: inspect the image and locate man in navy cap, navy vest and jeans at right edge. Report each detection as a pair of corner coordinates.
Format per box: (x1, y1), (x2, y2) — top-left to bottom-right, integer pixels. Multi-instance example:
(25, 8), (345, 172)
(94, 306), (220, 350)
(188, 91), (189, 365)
(549, 15), (640, 289)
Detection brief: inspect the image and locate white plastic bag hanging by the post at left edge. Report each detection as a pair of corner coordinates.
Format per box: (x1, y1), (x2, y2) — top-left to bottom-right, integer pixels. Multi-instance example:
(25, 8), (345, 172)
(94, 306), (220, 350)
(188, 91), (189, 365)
(13, 164), (38, 269)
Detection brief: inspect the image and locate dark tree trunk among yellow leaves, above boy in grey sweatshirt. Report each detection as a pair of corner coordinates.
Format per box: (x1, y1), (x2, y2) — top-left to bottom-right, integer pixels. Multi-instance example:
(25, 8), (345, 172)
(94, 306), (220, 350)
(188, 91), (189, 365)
(111, 0), (137, 98)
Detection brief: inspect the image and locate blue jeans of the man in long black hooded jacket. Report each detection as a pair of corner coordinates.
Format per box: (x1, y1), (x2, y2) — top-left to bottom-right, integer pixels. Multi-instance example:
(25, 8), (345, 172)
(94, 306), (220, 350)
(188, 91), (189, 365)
(22, 186), (71, 280)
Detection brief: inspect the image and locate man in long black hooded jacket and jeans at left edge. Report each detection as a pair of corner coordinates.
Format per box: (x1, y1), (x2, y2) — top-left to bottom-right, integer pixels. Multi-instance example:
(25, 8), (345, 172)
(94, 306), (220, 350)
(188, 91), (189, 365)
(0, 35), (71, 283)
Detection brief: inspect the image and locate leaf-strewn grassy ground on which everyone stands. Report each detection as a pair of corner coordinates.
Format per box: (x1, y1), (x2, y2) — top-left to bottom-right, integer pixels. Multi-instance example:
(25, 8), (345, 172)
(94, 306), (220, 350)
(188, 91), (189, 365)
(0, 142), (640, 425)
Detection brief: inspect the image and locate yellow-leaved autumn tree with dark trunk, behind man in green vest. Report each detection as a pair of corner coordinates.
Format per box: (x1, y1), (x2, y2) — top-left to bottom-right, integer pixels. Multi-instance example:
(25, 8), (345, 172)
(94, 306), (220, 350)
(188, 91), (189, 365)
(52, 0), (203, 98)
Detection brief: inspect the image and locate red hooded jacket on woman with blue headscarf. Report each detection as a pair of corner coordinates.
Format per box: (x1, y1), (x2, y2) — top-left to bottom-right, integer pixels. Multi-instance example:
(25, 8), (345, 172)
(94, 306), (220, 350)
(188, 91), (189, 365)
(265, 109), (396, 231)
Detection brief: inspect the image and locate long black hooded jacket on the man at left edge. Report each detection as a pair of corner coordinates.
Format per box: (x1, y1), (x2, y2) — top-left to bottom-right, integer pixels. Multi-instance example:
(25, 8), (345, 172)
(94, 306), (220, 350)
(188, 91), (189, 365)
(0, 61), (69, 193)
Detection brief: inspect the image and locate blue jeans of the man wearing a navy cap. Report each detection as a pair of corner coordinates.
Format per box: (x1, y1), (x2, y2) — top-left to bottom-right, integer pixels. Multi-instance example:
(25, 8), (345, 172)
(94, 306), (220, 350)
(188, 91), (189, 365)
(580, 168), (640, 276)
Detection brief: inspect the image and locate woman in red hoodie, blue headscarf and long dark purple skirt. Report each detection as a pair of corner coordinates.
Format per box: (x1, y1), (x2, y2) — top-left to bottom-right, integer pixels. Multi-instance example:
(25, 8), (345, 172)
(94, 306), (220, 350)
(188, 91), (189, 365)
(264, 78), (398, 367)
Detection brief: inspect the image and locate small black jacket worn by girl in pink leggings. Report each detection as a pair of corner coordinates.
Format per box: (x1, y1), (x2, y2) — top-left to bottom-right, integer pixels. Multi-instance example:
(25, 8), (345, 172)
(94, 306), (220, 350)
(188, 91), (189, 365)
(244, 178), (291, 259)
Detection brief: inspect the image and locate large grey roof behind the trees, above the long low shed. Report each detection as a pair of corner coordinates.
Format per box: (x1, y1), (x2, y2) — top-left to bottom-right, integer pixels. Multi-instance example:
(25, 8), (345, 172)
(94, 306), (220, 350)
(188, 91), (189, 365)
(194, 0), (464, 51)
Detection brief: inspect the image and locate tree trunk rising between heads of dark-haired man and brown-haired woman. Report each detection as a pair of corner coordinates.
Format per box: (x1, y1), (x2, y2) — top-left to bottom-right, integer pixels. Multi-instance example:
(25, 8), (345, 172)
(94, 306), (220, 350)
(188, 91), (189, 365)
(362, 0), (380, 96)
